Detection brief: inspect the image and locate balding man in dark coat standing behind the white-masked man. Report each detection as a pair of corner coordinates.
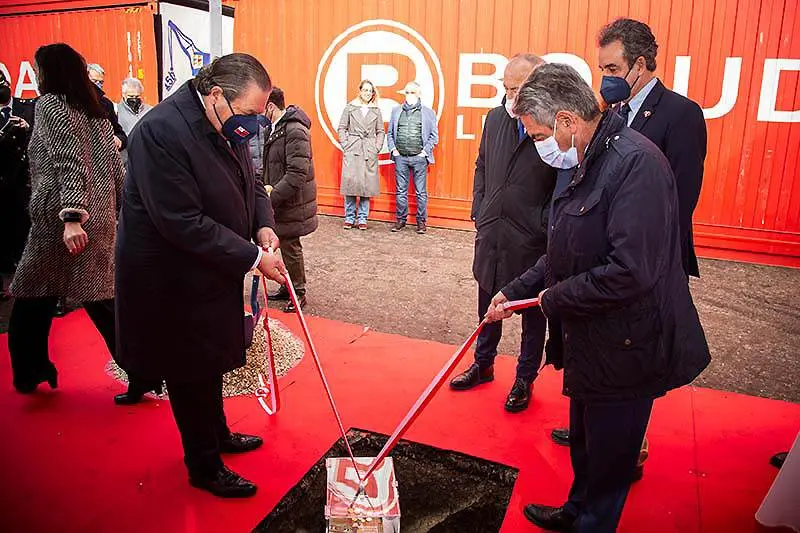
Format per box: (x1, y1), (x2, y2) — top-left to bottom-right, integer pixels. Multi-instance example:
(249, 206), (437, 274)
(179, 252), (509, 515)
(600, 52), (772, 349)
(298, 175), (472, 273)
(450, 54), (556, 413)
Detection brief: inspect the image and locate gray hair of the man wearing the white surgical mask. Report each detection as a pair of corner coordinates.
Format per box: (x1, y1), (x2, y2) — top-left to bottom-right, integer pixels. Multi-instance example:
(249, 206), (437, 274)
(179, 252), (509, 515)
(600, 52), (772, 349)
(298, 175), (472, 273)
(513, 64), (600, 127)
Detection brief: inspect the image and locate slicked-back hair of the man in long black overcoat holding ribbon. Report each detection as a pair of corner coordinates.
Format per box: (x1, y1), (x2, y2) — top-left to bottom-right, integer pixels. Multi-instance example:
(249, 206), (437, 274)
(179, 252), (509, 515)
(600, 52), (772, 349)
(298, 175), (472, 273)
(194, 53), (272, 100)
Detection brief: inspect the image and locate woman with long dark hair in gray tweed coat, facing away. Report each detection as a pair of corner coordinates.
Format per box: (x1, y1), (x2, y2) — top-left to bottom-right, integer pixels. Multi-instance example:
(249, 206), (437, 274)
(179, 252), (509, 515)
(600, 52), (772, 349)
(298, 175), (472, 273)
(8, 44), (124, 393)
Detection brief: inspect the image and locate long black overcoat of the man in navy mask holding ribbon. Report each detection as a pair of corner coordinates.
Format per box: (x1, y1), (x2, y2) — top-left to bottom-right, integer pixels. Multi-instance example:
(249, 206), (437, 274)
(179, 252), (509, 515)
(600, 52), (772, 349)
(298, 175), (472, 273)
(116, 81), (275, 381)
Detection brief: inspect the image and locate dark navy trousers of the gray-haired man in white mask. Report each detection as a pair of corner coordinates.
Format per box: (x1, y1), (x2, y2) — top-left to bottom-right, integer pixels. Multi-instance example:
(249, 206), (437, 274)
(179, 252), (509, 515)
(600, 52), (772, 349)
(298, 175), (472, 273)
(564, 399), (653, 533)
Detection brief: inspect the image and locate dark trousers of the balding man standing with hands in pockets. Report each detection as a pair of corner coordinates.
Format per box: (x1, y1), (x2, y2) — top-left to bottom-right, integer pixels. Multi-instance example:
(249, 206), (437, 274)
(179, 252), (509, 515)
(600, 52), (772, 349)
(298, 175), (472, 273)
(475, 287), (547, 383)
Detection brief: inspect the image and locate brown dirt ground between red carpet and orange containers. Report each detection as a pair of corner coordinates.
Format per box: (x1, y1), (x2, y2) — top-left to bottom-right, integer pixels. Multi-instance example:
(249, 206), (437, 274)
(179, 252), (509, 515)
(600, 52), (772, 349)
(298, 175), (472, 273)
(0, 217), (800, 402)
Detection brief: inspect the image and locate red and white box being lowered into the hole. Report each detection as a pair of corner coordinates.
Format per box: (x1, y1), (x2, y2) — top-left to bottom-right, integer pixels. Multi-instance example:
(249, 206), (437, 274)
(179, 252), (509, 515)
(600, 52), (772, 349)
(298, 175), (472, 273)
(325, 457), (400, 533)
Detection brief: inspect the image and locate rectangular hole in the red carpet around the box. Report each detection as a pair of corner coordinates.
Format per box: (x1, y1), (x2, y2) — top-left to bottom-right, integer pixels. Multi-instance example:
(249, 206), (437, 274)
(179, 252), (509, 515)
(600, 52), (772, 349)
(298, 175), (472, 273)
(253, 429), (519, 533)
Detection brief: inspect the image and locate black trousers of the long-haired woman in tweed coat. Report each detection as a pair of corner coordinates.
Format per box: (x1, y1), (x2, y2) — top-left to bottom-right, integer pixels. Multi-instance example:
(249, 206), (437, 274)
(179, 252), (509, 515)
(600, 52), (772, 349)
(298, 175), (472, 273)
(8, 296), (116, 383)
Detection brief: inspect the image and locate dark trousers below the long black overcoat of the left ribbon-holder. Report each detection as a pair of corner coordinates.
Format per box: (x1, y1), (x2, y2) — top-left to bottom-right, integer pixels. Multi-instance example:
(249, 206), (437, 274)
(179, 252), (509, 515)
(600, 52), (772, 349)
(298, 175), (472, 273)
(166, 374), (231, 478)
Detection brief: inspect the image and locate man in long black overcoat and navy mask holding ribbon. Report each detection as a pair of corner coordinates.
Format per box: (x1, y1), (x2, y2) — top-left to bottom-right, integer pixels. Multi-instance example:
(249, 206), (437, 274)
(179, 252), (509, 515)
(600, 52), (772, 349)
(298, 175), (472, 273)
(115, 54), (286, 498)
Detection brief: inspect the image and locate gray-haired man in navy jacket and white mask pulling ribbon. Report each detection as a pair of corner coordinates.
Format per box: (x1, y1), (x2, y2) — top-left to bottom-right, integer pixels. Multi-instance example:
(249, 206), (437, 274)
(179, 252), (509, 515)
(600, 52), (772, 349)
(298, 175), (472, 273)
(487, 65), (710, 533)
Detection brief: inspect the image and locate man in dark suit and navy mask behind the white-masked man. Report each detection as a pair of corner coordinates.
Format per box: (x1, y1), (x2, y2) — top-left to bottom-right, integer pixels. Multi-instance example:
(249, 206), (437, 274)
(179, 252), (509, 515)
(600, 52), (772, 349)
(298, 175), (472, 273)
(553, 19), (707, 477)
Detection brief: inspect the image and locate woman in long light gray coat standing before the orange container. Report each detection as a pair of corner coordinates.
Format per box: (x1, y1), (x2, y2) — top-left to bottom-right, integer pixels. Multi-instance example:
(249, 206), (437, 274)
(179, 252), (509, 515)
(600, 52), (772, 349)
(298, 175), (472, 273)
(339, 80), (386, 230)
